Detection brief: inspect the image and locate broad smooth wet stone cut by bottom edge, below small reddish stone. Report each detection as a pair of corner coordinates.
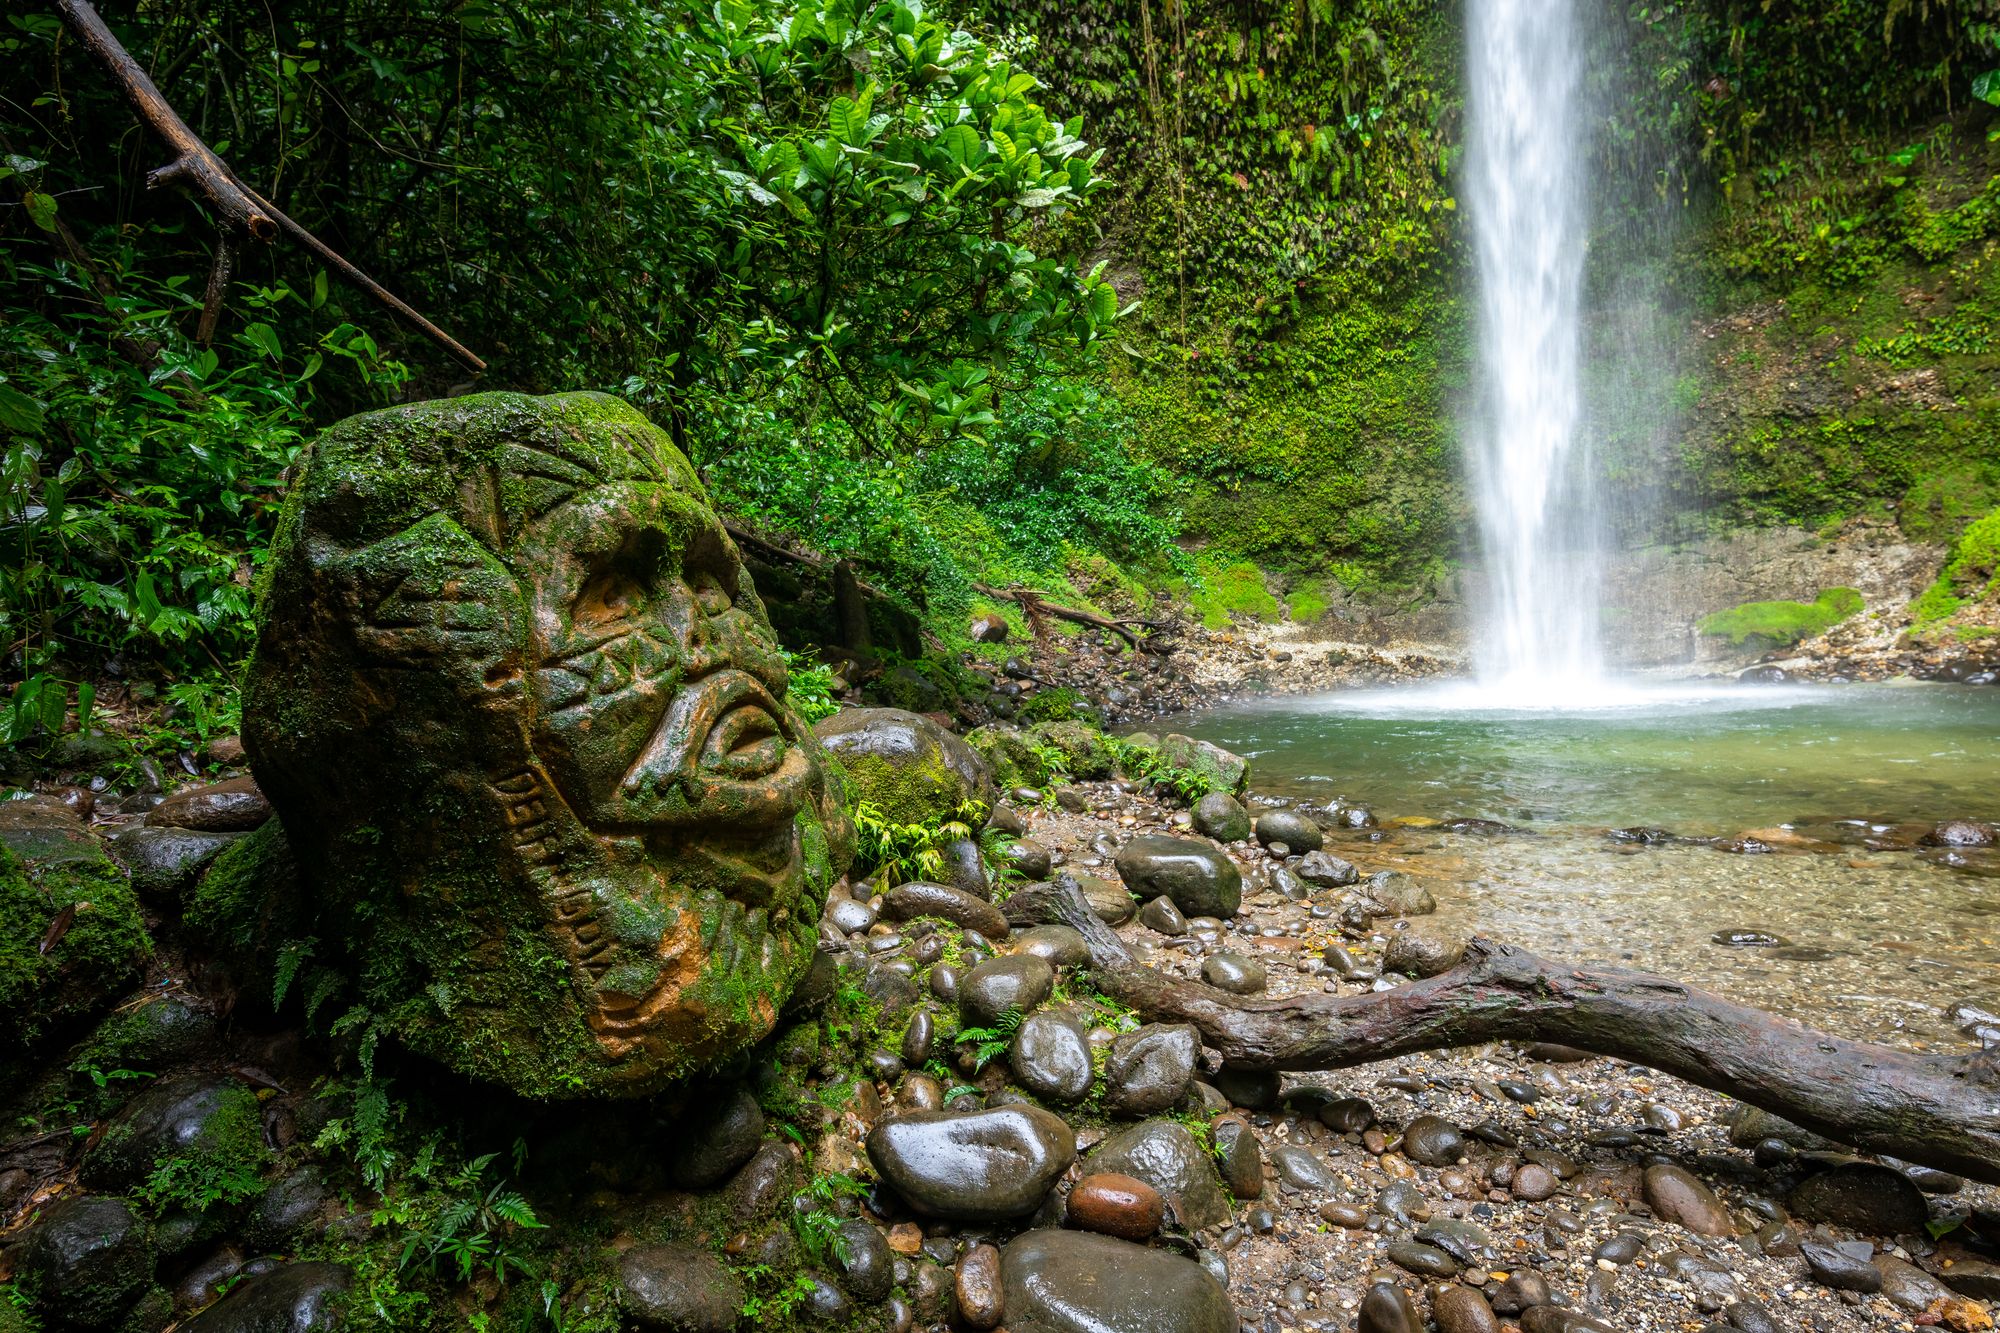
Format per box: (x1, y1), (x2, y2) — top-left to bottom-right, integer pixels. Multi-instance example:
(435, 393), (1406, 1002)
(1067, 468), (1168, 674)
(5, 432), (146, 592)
(1000, 1231), (1236, 1333)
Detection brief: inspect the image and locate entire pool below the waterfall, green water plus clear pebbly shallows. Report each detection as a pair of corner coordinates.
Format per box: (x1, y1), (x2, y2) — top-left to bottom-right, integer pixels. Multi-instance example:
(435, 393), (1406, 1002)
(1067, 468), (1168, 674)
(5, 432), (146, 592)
(1154, 685), (2000, 1047)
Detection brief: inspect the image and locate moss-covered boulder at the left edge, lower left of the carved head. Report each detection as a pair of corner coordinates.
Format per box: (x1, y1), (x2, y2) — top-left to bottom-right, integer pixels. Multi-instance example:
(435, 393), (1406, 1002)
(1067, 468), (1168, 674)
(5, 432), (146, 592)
(0, 801), (152, 1061)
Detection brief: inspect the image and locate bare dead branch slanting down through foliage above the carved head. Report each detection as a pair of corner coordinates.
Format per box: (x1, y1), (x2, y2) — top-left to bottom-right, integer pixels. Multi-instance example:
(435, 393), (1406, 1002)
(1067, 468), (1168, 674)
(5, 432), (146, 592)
(56, 0), (486, 370)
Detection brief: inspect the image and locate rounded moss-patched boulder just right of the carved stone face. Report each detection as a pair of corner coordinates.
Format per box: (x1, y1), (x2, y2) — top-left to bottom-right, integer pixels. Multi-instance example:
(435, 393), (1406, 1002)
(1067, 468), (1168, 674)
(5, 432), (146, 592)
(814, 709), (998, 825)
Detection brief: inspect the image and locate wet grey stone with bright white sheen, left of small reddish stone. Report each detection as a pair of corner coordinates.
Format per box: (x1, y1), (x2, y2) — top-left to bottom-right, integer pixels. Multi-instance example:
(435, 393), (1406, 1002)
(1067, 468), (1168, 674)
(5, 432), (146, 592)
(868, 1107), (1080, 1221)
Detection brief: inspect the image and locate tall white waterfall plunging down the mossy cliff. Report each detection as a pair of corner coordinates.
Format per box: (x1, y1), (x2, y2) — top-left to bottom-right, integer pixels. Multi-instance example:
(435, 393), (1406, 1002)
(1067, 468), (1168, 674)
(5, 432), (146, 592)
(1466, 0), (1604, 703)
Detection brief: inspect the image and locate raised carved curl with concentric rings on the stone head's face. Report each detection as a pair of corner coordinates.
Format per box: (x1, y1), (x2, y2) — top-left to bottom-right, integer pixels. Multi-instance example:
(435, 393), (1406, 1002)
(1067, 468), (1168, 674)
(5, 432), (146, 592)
(622, 669), (808, 823)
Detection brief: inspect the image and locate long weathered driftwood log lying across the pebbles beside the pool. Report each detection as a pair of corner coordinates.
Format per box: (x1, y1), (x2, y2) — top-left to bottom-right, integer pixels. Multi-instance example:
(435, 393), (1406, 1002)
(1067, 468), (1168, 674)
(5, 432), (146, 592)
(1008, 879), (2000, 1185)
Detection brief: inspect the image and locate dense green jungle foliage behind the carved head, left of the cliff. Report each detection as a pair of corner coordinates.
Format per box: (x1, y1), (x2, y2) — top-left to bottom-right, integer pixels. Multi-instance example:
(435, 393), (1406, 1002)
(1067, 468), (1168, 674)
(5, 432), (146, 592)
(0, 0), (1172, 741)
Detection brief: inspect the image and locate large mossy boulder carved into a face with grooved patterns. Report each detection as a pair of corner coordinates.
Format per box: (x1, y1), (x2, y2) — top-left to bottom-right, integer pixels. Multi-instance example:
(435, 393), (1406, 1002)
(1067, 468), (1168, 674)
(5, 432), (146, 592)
(244, 394), (852, 1097)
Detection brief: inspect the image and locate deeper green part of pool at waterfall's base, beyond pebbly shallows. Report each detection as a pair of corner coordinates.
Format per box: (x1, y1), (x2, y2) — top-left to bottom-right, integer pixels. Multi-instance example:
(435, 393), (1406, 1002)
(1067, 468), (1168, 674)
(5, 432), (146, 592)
(1148, 683), (2000, 835)
